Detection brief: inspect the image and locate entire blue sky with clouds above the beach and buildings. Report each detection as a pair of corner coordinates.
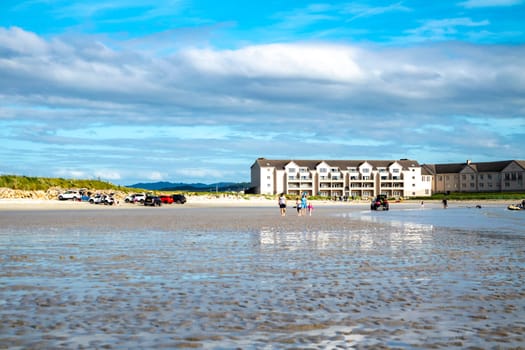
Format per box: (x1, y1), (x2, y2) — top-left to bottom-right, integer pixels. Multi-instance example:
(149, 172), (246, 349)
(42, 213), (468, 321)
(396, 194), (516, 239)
(0, 0), (525, 185)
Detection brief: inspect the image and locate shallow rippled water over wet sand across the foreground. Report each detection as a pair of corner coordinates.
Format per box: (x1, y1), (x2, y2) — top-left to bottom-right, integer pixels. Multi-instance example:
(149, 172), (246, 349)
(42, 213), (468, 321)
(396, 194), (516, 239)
(0, 208), (525, 349)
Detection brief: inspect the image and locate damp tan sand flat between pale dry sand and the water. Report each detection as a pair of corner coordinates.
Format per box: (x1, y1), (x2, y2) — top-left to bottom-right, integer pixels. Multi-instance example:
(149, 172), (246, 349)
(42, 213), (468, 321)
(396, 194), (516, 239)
(0, 205), (376, 232)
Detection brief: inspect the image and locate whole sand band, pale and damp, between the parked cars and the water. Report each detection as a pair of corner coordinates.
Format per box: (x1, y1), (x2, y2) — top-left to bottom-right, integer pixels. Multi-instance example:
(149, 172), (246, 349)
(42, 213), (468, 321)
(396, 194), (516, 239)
(0, 199), (500, 231)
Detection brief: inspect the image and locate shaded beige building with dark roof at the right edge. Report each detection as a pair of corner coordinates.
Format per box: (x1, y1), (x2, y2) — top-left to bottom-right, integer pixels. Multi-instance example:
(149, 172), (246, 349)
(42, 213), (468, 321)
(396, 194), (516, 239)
(422, 160), (525, 193)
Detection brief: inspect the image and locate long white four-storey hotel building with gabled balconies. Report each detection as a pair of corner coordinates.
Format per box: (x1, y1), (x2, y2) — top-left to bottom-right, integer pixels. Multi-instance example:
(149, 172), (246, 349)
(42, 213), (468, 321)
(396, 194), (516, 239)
(251, 158), (432, 198)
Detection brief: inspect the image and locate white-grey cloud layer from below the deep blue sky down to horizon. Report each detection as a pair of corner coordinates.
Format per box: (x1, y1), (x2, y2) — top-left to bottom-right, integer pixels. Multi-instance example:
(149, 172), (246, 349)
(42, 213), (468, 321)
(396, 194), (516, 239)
(0, 26), (525, 183)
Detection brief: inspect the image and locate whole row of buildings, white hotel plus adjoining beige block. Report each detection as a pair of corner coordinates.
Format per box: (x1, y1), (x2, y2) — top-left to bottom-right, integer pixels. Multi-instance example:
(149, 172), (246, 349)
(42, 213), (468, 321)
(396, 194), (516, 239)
(251, 158), (525, 198)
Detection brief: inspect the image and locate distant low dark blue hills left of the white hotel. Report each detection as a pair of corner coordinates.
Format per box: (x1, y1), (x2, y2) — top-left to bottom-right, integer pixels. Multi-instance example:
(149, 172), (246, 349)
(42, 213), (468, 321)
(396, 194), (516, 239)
(126, 181), (251, 192)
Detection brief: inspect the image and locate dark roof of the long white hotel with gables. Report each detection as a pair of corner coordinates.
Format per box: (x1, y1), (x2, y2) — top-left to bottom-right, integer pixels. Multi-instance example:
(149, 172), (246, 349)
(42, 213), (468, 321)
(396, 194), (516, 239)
(252, 158), (419, 169)
